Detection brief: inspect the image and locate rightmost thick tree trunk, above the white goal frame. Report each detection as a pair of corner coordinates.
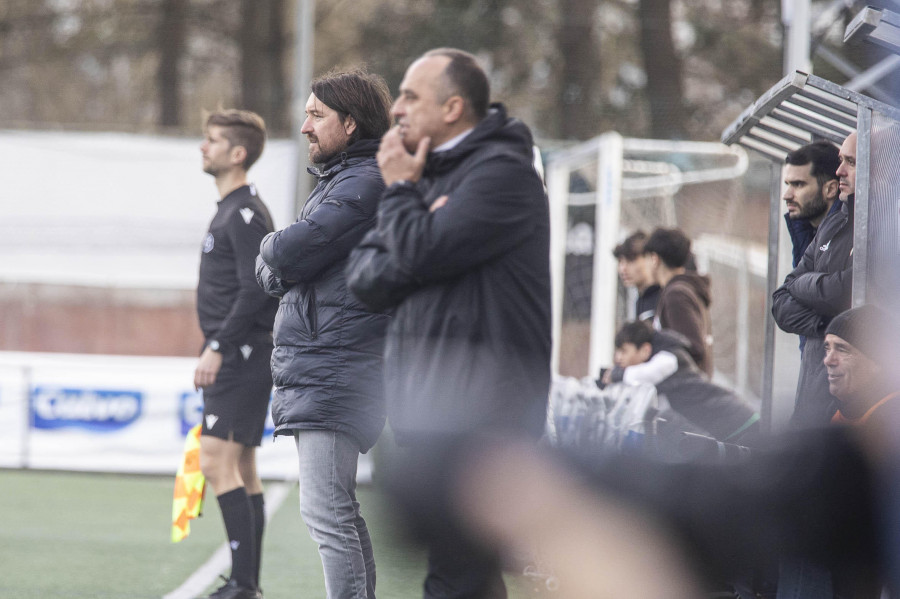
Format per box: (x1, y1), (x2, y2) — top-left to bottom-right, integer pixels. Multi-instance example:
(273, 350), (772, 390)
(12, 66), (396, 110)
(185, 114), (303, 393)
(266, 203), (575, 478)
(638, 0), (686, 139)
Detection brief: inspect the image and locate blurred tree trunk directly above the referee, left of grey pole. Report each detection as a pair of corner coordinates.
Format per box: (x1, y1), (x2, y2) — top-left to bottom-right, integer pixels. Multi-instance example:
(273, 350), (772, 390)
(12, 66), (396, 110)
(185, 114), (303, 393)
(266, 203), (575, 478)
(238, 0), (289, 134)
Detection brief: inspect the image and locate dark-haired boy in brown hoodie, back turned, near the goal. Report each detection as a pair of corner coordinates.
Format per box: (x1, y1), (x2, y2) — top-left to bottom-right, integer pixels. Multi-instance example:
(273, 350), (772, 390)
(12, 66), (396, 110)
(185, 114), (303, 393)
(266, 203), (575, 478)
(644, 228), (713, 376)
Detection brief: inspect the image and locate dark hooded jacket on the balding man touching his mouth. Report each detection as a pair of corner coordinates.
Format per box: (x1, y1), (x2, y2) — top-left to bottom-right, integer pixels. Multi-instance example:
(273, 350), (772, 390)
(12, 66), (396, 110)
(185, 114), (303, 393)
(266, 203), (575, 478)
(348, 105), (550, 443)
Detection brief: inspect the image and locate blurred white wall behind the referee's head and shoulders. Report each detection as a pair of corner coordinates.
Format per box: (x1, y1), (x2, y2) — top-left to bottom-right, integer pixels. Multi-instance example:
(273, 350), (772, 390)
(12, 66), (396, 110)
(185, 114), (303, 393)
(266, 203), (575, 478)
(0, 131), (306, 289)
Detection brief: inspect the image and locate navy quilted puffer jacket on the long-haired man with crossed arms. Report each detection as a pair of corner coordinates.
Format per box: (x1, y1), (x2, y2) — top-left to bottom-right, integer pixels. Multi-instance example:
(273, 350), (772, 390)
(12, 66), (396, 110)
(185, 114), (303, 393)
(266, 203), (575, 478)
(256, 140), (389, 452)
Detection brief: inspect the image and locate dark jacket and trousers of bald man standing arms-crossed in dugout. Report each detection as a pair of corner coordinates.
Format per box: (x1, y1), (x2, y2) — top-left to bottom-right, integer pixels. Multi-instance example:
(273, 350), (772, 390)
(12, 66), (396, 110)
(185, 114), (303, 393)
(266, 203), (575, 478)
(772, 196), (854, 428)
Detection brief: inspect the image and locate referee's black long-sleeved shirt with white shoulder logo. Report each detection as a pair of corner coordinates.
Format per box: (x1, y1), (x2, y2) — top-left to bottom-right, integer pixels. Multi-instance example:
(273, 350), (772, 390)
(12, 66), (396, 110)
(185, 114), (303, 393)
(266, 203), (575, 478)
(197, 185), (277, 351)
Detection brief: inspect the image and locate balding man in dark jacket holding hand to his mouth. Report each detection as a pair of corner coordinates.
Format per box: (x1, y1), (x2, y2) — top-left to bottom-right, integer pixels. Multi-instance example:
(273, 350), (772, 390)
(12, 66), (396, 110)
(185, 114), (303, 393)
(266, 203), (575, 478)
(348, 48), (551, 598)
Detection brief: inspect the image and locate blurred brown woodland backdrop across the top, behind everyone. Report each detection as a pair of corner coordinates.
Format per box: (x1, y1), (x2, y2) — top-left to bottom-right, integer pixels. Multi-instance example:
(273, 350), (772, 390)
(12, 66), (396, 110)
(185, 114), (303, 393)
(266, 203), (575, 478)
(0, 0), (856, 144)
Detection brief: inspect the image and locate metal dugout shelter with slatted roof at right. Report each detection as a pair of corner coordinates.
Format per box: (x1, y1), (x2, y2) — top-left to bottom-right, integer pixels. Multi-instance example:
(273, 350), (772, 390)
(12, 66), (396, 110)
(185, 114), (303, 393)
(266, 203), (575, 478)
(721, 71), (900, 430)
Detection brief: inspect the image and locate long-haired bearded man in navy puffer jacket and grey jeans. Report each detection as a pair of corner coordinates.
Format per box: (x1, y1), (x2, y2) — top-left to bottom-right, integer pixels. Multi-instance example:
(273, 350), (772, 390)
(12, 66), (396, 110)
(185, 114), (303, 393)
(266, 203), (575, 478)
(256, 71), (391, 599)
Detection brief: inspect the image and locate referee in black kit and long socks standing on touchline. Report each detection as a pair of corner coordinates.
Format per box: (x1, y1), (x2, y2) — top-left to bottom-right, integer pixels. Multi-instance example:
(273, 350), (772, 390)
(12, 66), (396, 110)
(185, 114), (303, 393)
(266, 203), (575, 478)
(194, 110), (278, 599)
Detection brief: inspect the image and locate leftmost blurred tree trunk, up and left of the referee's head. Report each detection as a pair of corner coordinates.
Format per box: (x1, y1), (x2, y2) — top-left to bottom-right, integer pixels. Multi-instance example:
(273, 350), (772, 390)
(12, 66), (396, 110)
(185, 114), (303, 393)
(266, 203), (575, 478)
(156, 0), (188, 127)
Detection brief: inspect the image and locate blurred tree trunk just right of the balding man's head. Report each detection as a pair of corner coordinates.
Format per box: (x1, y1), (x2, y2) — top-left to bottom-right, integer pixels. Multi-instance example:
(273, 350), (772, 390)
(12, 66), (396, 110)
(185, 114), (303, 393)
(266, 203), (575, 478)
(557, 0), (600, 139)
